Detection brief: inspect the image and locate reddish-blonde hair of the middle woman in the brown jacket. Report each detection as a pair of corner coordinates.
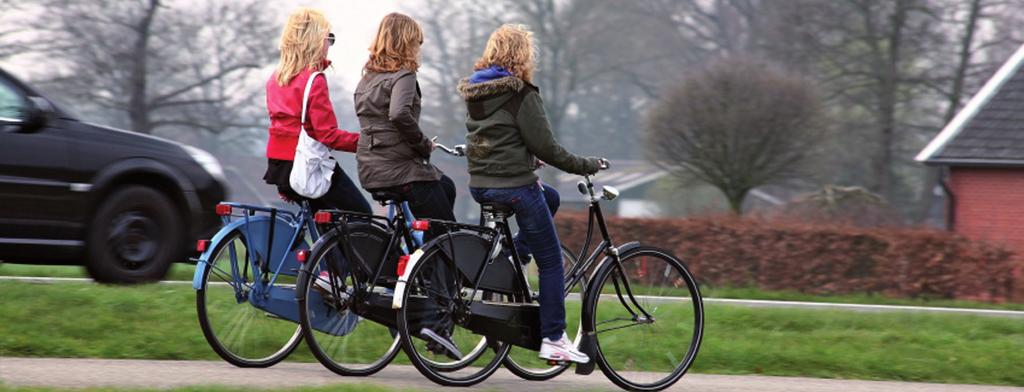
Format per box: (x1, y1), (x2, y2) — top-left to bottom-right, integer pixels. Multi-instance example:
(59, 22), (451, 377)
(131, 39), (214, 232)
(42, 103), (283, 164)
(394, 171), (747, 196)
(362, 12), (423, 73)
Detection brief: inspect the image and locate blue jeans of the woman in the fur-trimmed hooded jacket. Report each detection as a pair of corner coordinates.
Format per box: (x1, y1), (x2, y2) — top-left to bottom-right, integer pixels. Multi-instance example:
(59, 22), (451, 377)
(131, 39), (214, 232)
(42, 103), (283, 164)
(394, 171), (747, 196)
(469, 183), (565, 340)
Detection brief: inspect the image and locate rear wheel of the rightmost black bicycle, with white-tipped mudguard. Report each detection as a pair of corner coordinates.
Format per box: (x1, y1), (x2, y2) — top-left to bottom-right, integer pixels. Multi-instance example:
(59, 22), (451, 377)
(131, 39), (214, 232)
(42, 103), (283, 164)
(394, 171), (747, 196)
(398, 239), (509, 387)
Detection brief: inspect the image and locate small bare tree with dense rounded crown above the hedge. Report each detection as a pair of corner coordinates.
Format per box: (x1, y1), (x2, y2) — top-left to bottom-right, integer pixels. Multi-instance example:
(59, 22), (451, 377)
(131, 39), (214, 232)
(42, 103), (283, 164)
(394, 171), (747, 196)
(646, 58), (821, 214)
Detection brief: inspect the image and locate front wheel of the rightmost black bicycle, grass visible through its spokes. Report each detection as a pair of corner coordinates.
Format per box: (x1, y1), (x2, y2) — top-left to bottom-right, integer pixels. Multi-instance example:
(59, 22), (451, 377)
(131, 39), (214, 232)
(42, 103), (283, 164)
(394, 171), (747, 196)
(585, 247), (703, 391)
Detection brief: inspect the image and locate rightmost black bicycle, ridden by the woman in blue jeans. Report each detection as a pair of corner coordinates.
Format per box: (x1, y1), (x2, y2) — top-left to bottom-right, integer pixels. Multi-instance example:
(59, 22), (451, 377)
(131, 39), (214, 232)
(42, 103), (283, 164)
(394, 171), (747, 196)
(394, 161), (703, 391)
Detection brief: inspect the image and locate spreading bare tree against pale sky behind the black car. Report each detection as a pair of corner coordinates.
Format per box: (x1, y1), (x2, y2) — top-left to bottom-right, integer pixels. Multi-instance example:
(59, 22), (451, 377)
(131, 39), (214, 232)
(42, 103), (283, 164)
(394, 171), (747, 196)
(24, 0), (278, 133)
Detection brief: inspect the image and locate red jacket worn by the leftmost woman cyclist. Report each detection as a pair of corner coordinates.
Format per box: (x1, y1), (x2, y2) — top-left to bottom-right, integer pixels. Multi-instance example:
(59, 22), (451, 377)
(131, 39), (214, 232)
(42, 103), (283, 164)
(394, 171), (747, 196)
(266, 64), (359, 161)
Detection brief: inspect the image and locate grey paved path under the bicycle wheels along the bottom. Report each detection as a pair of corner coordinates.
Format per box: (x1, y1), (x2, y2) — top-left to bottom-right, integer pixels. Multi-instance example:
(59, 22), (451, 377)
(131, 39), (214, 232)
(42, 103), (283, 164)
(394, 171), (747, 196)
(0, 357), (1024, 392)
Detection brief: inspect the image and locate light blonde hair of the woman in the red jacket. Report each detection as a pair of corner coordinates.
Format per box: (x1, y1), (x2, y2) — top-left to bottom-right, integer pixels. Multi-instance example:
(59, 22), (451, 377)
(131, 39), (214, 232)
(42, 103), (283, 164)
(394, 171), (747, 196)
(276, 7), (331, 86)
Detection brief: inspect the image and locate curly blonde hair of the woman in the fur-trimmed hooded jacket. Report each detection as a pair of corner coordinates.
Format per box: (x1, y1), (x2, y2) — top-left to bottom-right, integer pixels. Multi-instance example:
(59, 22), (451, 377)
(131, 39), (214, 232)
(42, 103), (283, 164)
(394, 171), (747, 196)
(473, 25), (536, 82)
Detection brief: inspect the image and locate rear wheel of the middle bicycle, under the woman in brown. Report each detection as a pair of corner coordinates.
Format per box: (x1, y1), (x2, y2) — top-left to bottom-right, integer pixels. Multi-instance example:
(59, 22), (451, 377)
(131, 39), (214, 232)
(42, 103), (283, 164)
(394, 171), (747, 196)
(298, 227), (399, 376)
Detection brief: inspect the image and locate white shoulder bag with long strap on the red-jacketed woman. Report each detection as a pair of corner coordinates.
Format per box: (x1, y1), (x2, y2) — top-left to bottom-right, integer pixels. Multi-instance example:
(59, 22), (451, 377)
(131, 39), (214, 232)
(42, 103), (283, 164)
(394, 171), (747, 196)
(288, 72), (335, 199)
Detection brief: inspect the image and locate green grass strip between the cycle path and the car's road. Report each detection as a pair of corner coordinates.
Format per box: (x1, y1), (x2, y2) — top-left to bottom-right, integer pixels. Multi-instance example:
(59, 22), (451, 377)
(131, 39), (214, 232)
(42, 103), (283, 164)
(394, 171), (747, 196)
(0, 281), (1024, 386)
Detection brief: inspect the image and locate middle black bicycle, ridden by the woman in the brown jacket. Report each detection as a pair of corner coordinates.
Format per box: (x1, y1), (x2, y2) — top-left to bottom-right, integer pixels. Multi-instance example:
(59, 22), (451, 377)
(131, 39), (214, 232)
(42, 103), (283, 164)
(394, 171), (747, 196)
(296, 145), (487, 376)
